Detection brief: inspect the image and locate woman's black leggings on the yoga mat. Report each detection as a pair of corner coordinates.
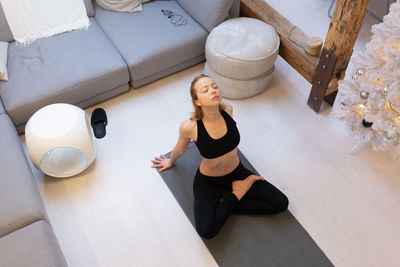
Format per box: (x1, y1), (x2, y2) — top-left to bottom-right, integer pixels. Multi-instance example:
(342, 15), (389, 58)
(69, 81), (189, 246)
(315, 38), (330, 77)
(193, 163), (289, 238)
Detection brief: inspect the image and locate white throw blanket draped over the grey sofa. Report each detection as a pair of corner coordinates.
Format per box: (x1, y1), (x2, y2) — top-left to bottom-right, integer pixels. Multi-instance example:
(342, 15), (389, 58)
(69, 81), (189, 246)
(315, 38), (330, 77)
(0, 0), (89, 45)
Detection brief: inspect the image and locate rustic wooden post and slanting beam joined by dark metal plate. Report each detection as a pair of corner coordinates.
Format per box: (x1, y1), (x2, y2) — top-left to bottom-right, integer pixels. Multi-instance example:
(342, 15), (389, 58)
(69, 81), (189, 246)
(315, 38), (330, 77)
(240, 0), (369, 112)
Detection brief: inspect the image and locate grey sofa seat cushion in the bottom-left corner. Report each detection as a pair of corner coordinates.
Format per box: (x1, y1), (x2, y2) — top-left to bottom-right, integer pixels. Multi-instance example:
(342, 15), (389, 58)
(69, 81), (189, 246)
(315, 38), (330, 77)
(0, 221), (67, 267)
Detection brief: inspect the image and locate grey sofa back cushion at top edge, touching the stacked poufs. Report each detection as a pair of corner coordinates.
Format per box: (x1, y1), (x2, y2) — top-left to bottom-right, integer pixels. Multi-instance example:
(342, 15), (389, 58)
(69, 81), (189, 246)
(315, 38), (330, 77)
(177, 0), (233, 32)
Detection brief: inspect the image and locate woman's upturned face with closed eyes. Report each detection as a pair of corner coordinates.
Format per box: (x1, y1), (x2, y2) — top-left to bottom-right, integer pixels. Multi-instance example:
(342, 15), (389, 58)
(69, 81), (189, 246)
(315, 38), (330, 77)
(194, 77), (222, 107)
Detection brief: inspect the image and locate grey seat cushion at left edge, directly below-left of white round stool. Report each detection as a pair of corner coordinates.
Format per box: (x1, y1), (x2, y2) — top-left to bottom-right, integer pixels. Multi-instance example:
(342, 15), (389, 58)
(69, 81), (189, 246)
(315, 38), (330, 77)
(0, 114), (47, 239)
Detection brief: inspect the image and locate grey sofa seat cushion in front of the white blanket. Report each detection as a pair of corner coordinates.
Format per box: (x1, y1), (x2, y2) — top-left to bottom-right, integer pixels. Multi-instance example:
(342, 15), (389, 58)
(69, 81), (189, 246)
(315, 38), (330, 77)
(0, 18), (129, 129)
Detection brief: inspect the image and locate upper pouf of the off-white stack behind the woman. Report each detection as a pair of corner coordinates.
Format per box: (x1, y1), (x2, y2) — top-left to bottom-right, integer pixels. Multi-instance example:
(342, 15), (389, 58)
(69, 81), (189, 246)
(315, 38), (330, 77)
(205, 17), (280, 80)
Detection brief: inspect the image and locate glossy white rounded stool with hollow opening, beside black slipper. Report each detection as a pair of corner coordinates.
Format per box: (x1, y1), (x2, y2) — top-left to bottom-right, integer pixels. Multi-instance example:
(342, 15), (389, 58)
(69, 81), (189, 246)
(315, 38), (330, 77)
(25, 103), (96, 177)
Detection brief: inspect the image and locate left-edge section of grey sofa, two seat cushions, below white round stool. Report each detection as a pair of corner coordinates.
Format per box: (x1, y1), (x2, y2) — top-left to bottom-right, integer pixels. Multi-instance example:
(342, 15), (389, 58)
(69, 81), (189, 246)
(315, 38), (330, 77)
(0, 108), (67, 267)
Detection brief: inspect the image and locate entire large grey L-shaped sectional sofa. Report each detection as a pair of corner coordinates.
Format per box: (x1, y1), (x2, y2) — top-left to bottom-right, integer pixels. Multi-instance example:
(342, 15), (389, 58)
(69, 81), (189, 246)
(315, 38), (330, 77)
(0, 0), (240, 267)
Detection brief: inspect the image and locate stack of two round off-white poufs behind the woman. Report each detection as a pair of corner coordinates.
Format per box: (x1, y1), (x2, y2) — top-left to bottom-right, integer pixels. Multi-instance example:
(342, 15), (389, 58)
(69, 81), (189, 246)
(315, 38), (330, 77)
(204, 17), (280, 99)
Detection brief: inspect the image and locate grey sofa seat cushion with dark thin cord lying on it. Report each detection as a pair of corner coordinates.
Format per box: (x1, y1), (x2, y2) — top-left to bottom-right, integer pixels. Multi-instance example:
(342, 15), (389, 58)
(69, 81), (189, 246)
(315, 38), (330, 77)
(95, 1), (208, 87)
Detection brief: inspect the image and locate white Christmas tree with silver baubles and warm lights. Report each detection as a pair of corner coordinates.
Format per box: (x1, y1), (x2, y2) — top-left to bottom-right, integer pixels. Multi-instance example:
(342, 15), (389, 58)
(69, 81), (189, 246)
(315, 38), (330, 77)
(332, 0), (400, 155)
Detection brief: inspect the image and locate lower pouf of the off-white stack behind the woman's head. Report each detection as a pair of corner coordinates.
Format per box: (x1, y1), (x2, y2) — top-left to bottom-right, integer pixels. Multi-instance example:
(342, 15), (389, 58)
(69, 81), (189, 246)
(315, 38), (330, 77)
(204, 63), (274, 99)
